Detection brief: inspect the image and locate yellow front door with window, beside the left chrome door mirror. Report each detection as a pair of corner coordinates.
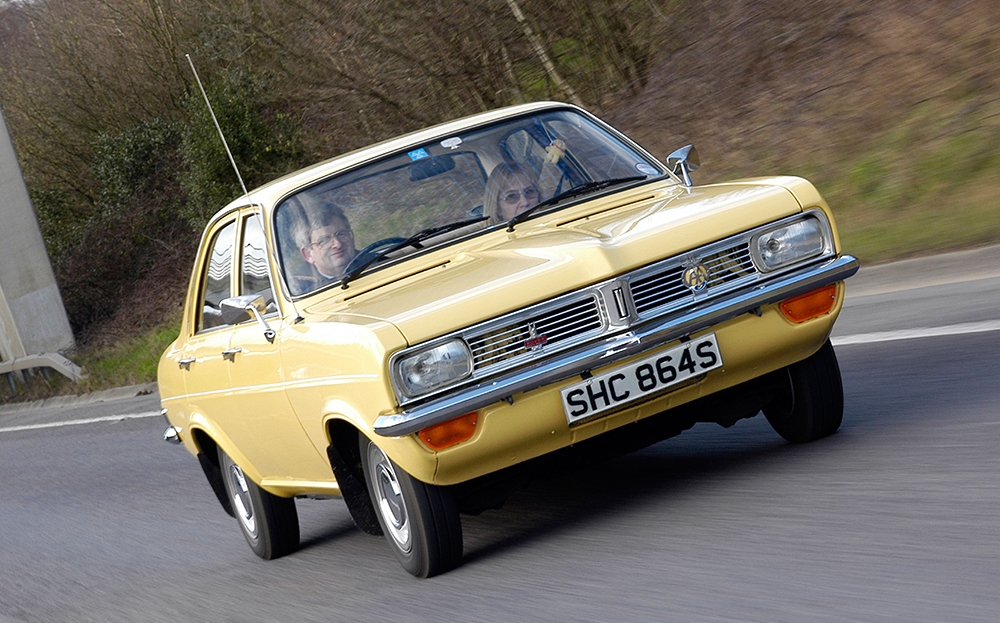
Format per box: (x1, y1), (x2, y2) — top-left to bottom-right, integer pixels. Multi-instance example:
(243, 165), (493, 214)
(218, 211), (333, 486)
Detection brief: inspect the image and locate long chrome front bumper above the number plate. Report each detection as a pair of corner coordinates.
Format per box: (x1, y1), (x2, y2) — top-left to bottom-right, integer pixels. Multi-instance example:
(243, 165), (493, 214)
(374, 255), (860, 437)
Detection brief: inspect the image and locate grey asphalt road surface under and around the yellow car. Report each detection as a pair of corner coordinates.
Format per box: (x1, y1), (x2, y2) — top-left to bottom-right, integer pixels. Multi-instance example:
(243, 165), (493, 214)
(0, 250), (1000, 623)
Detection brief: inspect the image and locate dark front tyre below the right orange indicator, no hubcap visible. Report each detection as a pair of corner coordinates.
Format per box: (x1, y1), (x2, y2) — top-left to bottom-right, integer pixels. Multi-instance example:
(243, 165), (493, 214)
(764, 340), (844, 443)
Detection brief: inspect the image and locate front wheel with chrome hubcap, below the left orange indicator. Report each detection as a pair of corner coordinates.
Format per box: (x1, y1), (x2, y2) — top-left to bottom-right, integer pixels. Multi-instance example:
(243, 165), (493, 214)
(360, 435), (462, 578)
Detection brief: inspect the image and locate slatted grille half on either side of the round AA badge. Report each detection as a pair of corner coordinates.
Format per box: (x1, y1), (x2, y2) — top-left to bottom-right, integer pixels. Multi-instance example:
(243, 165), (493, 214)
(630, 243), (757, 316)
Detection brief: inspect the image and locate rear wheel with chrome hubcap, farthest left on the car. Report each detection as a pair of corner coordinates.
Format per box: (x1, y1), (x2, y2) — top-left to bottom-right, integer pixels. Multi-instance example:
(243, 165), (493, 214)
(219, 448), (299, 560)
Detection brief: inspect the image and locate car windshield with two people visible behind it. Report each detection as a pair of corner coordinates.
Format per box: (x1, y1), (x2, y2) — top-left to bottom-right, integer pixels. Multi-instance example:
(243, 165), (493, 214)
(275, 110), (665, 295)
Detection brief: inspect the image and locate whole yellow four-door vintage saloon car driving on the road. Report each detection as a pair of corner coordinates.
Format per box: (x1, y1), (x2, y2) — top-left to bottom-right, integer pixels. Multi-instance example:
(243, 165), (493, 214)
(159, 103), (858, 577)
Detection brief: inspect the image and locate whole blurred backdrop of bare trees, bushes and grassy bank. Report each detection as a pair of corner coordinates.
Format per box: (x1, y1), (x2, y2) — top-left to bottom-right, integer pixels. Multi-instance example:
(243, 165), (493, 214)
(0, 0), (1000, 376)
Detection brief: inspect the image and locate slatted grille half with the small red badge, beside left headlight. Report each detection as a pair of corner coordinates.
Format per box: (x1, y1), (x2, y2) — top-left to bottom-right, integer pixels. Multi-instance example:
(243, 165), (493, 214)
(466, 297), (604, 371)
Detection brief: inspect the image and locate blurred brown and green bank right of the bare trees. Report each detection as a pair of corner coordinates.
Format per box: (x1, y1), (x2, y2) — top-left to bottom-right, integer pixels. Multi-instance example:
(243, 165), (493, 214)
(608, 0), (1000, 262)
